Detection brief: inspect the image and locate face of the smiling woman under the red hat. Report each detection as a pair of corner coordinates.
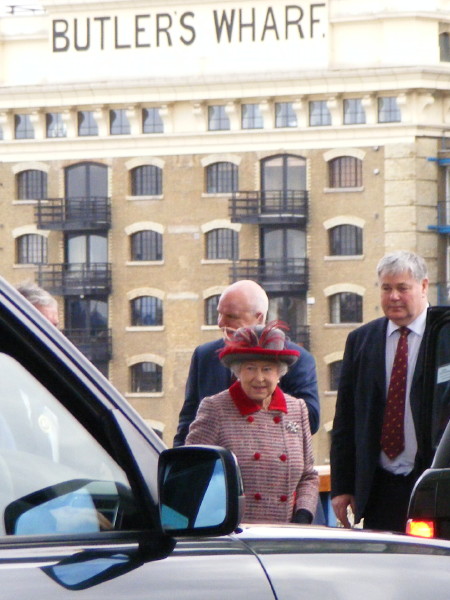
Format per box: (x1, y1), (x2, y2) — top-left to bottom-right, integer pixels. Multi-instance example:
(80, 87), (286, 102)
(239, 360), (280, 404)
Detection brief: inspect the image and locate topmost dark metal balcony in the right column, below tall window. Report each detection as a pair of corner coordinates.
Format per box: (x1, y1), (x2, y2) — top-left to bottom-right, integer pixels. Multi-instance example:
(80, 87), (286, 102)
(228, 190), (308, 225)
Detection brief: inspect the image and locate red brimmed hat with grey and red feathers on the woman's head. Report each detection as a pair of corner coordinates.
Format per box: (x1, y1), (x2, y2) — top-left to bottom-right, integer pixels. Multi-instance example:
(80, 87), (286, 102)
(219, 321), (300, 367)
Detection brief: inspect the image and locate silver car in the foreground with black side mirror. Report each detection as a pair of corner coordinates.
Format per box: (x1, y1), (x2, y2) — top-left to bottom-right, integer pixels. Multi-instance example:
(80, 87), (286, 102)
(0, 280), (450, 600)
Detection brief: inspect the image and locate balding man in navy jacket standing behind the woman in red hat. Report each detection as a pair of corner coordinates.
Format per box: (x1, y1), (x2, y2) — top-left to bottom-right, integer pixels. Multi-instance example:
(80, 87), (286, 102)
(174, 280), (320, 446)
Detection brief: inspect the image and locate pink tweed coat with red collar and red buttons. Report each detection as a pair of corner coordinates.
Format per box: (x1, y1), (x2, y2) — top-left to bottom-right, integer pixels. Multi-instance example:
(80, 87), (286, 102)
(186, 384), (319, 523)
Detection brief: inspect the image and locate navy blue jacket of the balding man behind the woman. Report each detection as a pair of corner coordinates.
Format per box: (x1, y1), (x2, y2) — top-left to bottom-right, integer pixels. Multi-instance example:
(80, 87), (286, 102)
(173, 339), (320, 446)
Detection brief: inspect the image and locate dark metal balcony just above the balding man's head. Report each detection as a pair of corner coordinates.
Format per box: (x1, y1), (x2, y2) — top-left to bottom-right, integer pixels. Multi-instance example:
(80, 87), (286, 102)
(230, 258), (308, 293)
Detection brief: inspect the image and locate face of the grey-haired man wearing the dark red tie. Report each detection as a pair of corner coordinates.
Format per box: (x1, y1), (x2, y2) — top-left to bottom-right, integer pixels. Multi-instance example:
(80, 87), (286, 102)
(380, 272), (428, 326)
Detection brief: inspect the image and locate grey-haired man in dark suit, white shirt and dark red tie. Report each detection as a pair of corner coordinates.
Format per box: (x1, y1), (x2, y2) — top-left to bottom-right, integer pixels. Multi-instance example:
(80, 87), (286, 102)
(330, 251), (428, 532)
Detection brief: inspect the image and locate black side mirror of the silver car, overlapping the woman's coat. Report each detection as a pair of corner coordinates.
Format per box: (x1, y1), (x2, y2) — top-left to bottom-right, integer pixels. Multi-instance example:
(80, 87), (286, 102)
(158, 446), (244, 536)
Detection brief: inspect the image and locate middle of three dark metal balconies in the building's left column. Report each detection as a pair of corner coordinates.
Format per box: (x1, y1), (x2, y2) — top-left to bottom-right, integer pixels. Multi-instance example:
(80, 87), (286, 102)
(37, 263), (111, 296)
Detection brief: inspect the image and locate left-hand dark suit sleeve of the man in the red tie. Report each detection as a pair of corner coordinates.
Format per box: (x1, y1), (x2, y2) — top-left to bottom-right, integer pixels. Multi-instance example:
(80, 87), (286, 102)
(330, 334), (356, 498)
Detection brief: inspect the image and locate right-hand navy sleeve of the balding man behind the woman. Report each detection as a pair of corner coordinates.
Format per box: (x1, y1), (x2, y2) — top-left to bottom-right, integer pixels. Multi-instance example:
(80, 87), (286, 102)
(280, 344), (320, 434)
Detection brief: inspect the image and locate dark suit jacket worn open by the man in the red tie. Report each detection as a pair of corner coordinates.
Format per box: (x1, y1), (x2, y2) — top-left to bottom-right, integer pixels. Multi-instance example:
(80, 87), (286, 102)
(330, 317), (424, 522)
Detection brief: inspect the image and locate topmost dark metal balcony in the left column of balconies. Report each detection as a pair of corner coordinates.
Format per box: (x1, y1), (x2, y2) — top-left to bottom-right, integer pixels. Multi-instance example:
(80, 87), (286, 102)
(35, 196), (111, 231)
